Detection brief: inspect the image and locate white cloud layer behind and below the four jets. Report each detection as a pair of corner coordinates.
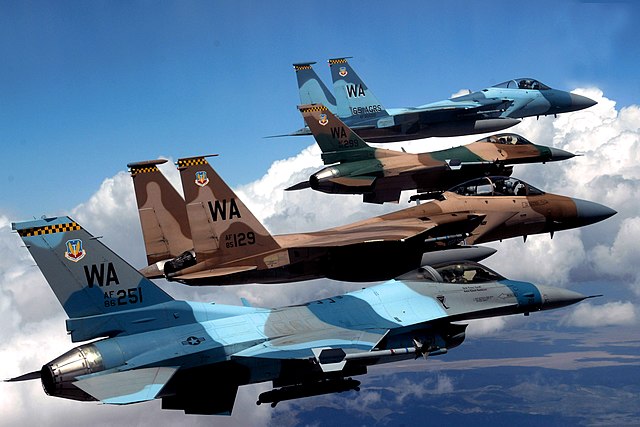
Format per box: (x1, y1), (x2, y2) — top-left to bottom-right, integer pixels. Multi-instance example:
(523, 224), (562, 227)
(0, 88), (640, 426)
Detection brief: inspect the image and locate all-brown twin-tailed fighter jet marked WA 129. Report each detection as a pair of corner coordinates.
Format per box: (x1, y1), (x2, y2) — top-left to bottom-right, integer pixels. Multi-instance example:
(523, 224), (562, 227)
(128, 156), (615, 285)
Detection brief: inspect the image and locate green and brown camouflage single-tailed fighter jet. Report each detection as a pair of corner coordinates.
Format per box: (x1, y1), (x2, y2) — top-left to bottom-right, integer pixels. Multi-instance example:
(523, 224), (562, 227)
(286, 104), (574, 203)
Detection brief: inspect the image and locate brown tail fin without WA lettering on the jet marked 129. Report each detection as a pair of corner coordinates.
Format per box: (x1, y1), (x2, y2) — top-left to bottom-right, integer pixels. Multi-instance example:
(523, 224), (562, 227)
(127, 160), (193, 272)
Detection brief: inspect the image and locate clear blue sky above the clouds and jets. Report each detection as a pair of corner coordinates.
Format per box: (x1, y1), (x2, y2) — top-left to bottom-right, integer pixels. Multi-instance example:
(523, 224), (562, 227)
(0, 1), (640, 218)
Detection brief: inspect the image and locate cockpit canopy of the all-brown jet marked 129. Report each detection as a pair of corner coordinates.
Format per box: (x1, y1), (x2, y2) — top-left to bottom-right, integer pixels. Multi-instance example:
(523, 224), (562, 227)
(449, 176), (544, 197)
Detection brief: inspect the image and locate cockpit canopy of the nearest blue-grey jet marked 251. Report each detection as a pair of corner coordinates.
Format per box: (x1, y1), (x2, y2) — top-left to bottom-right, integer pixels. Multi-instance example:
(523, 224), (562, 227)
(398, 261), (504, 283)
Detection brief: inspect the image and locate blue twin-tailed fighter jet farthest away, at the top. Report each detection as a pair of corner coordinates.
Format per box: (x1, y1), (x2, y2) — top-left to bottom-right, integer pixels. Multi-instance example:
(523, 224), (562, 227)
(290, 58), (596, 142)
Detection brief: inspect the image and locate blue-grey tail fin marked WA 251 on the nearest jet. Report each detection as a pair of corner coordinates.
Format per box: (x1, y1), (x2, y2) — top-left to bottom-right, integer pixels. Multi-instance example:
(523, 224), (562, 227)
(12, 217), (173, 318)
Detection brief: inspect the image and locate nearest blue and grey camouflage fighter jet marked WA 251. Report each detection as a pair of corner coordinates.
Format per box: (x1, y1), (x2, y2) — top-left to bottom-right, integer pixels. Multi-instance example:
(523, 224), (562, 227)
(7, 217), (589, 415)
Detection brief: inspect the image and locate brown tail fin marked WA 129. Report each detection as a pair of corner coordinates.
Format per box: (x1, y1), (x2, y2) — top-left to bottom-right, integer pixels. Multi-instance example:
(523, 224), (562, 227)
(178, 156), (280, 265)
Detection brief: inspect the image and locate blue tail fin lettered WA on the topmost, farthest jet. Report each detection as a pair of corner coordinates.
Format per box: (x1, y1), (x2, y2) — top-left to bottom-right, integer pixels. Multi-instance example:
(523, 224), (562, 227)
(329, 58), (389, 123)
